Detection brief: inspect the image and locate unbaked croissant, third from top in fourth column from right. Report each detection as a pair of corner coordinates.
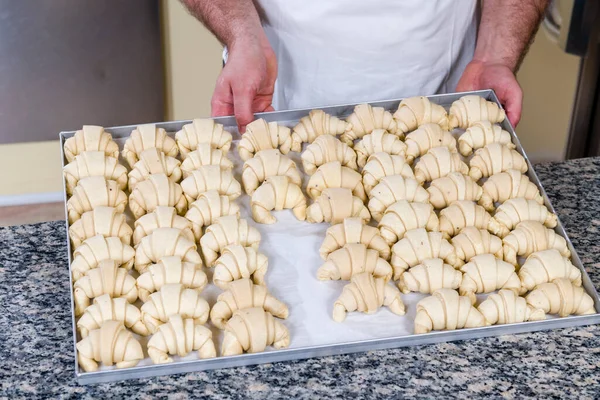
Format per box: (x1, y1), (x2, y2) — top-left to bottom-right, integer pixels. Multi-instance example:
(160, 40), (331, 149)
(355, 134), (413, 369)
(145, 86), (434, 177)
(306, 161), (367, 202)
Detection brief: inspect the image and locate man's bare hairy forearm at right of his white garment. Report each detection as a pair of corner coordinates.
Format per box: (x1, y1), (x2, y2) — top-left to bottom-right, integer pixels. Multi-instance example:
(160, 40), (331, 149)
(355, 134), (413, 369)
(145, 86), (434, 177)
(473, 0), (548, 72)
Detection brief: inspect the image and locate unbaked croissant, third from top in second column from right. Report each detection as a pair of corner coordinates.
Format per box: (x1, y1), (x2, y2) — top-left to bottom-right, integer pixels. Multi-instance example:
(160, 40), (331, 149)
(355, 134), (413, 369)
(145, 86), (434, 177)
(415, 147), (469, 183)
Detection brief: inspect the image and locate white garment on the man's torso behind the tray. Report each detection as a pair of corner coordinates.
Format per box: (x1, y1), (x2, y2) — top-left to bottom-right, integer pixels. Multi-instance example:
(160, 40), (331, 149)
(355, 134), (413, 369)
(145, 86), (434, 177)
(258, 0), (478, 110)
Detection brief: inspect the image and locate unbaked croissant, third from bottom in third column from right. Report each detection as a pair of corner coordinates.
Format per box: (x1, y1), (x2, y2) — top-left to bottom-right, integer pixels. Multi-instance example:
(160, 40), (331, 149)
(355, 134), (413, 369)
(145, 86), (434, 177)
(391, 228), (463, 280)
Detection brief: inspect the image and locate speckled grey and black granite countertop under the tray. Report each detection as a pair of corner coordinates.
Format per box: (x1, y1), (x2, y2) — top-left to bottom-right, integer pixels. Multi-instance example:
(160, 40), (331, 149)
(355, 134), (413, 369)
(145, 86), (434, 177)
(0, 158), (600, 398)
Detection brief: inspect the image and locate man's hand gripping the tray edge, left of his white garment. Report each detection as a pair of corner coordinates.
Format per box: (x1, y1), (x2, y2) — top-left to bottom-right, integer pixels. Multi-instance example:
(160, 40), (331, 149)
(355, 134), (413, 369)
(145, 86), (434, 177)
(211, 37), (277, 133)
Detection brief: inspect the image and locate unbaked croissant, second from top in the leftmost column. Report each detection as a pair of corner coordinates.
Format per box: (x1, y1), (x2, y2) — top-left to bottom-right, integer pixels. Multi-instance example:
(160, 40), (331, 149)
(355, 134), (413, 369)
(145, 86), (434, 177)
(63, 151), (127, 195)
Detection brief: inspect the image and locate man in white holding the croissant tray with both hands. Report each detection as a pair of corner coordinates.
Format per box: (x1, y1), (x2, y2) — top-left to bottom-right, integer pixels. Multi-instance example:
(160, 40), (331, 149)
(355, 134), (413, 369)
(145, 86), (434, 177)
(182, 0), (548, 130)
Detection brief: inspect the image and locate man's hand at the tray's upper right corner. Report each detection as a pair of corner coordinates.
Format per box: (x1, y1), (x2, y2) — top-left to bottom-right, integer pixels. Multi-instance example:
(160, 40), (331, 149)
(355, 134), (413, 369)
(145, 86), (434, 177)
(456, 60), (523, 127)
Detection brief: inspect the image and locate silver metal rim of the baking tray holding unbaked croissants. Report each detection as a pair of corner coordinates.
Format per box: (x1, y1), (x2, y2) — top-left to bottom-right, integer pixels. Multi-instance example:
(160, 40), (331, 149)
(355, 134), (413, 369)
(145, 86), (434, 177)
(60, 90), (600, 384)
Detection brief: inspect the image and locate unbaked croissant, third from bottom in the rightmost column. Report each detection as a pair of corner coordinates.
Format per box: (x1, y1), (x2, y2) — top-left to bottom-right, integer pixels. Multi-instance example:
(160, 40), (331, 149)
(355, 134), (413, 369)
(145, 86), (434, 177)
(502, 221), (571, 265)
